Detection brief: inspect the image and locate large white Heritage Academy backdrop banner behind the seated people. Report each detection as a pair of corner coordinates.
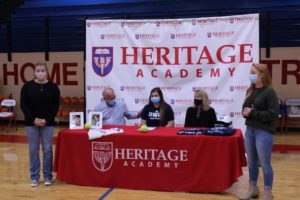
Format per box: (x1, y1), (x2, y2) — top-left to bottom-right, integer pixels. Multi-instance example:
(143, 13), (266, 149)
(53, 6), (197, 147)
(85, 14), (259, 129)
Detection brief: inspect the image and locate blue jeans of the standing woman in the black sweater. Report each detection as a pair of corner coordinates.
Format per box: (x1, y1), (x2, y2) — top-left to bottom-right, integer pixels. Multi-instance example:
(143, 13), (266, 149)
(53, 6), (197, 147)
(25, 126), (54, 181)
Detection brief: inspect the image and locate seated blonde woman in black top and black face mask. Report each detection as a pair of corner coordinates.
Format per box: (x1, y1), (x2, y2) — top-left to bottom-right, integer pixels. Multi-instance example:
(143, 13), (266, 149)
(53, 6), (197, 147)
(184, 90), (217, 128)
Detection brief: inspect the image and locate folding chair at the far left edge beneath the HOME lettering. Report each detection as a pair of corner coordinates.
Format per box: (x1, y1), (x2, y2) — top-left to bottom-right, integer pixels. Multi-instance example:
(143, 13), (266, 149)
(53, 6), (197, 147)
(0, 99), (17, 131)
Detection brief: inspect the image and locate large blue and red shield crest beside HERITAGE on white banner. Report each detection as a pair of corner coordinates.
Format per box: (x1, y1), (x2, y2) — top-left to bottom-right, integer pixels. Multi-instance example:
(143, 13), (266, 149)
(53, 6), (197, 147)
(92, 47), (113, 76)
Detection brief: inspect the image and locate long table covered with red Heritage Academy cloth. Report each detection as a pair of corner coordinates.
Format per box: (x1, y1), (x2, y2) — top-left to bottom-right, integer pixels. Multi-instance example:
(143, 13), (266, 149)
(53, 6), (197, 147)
(54, 126), (246, 192)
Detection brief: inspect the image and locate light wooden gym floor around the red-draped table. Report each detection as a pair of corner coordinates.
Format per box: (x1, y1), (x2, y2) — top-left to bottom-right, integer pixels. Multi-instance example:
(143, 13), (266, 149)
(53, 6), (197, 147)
(0, 126), (300, 200)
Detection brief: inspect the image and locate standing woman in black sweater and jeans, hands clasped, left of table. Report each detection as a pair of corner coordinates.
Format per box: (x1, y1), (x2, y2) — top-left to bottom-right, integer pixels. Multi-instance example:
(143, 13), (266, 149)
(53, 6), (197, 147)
(21, 62), (60, 187)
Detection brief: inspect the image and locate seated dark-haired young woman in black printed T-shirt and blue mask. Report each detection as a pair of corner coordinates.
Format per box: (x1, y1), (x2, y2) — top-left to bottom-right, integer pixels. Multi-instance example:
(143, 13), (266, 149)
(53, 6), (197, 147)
(141, 87), (174, 127)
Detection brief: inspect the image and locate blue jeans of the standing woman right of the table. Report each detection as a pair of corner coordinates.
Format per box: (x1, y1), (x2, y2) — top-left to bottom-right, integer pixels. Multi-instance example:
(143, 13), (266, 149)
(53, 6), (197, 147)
(245, 126), (273, 190)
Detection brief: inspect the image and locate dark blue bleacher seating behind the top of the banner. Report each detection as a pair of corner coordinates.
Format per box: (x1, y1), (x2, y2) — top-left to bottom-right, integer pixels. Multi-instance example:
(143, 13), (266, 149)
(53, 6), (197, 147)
(0, 0), (300, 52)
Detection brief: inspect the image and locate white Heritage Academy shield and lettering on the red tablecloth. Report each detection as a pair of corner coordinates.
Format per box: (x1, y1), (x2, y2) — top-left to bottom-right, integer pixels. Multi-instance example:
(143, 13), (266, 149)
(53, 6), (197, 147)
(92, 142), (189, 172)
